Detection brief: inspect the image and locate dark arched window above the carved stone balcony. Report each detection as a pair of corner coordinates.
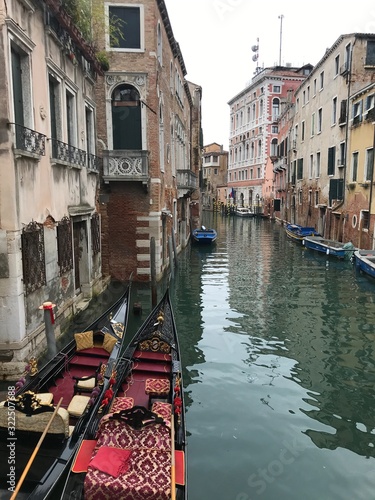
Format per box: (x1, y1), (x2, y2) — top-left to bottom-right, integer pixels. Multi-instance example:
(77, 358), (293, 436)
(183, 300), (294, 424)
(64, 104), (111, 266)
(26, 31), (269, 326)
(112, 84), (142, 149)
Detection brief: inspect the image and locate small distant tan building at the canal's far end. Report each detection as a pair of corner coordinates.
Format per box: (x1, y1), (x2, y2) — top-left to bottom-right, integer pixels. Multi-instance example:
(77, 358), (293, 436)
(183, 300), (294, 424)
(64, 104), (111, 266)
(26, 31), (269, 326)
(201, 142), (228, 210)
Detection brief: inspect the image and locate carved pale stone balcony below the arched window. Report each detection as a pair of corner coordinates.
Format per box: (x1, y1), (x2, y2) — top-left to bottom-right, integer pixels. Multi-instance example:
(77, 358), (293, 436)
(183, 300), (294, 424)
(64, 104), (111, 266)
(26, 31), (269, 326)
(103, 149), (148, 183)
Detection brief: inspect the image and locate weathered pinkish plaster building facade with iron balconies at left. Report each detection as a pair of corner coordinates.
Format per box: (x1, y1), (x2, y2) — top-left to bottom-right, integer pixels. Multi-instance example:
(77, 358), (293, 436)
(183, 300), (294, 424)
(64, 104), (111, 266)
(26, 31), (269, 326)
(0, 0), (104, 378)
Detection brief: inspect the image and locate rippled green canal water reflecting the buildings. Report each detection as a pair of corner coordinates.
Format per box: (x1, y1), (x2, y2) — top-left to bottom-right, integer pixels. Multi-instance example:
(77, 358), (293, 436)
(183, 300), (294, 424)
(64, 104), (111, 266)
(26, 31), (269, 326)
(167, 214), (375, 500)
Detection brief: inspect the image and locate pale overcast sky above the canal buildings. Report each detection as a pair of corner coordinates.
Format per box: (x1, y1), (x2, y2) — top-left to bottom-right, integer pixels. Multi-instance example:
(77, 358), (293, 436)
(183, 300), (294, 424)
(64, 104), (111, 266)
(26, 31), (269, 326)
(165, 0), (375, 150)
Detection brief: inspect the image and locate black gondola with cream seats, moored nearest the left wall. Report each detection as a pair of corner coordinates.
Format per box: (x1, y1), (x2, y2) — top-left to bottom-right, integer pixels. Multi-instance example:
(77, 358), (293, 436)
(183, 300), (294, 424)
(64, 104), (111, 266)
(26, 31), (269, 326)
(0, 284), (130, 500)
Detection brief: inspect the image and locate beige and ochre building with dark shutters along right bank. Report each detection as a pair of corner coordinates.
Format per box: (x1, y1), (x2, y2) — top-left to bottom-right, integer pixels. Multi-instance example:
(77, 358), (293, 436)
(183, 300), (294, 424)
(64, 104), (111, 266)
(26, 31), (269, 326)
(287, 34), (375, 248)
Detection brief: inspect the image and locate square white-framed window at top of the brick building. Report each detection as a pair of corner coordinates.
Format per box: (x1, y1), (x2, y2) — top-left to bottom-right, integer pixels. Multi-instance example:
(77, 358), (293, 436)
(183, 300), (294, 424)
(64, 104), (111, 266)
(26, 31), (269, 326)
(106, 5), (143, 51)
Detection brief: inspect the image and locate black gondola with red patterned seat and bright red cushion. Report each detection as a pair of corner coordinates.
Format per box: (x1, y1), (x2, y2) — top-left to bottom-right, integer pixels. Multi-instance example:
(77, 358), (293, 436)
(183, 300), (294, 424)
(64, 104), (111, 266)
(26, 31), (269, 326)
(61, 290), (187, 500)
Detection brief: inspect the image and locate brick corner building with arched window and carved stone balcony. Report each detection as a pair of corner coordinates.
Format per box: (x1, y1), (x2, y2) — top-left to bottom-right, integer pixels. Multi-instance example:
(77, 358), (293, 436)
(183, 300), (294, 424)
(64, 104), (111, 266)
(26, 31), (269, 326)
(96, 0), (202, 281)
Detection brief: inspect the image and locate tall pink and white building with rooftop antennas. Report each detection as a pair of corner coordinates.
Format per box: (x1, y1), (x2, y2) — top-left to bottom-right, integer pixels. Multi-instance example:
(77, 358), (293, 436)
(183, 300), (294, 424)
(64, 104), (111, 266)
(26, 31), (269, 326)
(228, 65), (312, 214)
